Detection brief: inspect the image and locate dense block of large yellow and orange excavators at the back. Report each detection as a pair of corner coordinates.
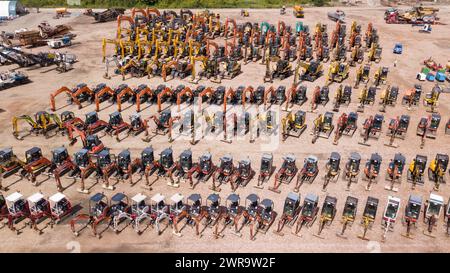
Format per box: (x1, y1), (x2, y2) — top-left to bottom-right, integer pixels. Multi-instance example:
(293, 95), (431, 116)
(103, 8), (382, 85)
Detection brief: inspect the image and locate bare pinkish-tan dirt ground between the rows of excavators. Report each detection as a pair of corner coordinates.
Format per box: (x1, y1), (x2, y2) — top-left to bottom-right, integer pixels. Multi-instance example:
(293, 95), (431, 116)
(0, 4), (450, 252)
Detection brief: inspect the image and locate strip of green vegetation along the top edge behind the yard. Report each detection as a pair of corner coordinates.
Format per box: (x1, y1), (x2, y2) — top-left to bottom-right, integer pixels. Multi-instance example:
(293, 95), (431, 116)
(20, 0), (330, 8)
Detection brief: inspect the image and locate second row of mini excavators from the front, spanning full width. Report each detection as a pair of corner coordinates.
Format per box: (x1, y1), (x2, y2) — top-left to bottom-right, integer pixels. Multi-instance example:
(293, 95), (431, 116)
(0, 143), (449, 196)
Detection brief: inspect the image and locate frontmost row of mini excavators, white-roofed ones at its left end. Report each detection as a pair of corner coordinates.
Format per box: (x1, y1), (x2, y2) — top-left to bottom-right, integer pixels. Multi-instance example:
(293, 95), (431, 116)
(0, 188), (450, 239)
